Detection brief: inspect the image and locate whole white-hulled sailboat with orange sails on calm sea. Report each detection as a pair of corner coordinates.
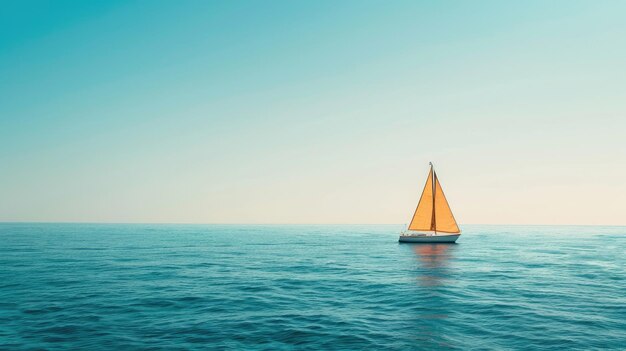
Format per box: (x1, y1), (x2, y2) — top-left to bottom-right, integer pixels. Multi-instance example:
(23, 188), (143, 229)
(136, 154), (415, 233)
(398, 162), (461, 243)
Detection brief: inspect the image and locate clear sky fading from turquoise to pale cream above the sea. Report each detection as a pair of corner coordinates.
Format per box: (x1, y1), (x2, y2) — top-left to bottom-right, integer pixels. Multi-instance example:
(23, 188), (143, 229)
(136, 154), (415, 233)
(0, 0), (626, 227)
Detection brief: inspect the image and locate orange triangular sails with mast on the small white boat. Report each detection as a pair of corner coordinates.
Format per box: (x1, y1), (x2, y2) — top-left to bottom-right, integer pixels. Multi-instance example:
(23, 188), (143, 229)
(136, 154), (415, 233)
(409, 164), (461, 233)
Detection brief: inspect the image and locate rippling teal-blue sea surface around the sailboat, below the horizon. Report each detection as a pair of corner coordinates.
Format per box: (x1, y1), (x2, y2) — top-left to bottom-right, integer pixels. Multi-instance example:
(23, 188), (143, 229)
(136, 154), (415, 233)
(0, 223), (626, 350)
